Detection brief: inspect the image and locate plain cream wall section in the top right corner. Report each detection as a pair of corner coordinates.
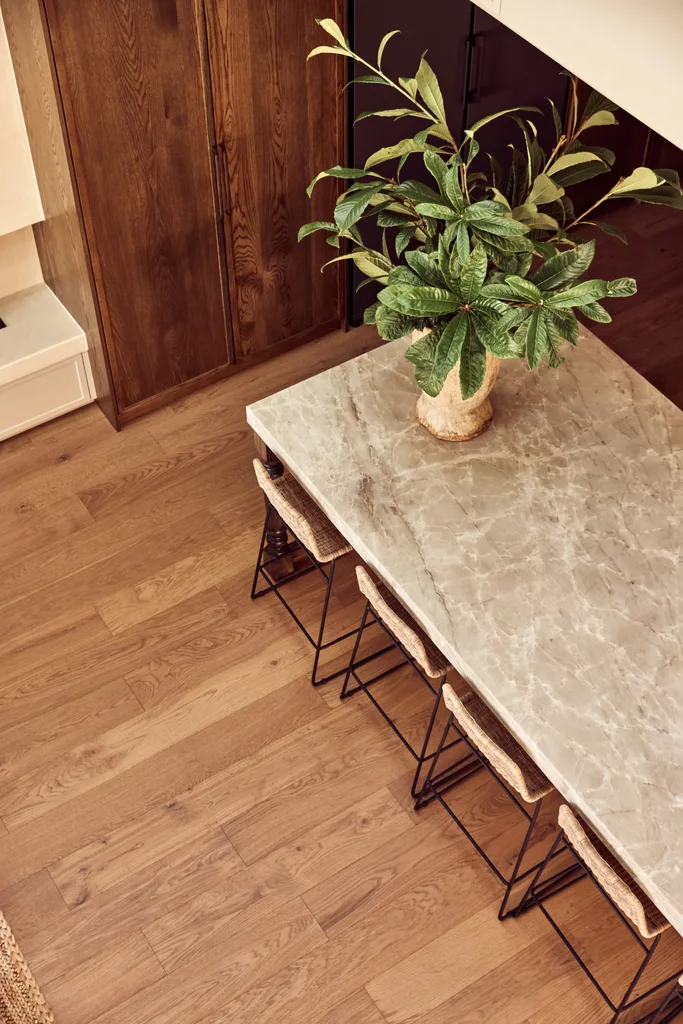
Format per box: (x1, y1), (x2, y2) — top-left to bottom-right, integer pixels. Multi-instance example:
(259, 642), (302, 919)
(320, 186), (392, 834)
(474, 0), (683, 148)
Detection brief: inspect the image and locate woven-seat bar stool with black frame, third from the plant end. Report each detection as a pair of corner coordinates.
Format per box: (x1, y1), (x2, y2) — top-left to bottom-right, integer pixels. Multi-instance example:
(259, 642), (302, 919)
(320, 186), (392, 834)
(415, 683), (575, 921)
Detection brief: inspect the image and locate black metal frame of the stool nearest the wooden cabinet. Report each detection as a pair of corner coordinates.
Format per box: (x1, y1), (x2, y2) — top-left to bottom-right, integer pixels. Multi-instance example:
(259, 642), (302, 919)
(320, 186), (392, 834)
(251, 498), (389, 686)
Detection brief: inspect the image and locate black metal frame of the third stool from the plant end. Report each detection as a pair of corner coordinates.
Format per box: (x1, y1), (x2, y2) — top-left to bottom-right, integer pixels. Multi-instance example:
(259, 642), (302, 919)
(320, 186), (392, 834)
(415, 692), (578, 921)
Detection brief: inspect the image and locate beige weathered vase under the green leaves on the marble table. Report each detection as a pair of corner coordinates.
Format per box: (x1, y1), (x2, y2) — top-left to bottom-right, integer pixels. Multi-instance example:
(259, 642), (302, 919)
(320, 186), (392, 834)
(415, 332), (501, 441)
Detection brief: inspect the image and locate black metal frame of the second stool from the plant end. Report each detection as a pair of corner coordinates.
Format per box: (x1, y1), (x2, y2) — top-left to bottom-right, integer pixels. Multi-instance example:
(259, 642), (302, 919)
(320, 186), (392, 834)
(339, 601), (480, 798)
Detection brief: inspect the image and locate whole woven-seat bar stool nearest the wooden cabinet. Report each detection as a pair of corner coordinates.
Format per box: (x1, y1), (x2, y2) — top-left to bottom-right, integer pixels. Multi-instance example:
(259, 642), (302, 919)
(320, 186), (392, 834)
(251, 459), (355, 686)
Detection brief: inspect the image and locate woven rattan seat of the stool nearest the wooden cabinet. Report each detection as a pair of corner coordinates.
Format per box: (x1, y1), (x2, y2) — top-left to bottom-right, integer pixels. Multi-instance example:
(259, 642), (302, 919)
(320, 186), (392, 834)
(254, 459), (352, 562)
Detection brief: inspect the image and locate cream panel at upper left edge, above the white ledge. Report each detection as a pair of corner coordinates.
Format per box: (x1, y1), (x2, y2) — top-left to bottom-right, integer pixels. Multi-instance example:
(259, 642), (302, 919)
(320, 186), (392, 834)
(0, 8), (43, 234)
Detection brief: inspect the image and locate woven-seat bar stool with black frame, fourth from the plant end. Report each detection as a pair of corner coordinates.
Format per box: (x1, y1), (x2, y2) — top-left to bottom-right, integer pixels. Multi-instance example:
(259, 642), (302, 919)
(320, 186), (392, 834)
(516, 804), (681, 1024)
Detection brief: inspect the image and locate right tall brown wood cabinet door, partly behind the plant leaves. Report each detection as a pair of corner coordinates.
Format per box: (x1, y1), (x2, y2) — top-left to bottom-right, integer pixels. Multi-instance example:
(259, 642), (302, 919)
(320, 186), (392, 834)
(206, 0), (345, 359)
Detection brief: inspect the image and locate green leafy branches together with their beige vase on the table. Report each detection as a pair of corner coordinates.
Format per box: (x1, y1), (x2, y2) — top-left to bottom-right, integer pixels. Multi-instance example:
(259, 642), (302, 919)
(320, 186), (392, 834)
(299, 18), (683, 440)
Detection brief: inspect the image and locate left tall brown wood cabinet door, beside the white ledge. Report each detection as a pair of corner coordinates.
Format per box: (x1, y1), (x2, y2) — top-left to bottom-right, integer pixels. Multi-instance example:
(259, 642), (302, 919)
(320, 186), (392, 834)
(45, 0), (229, 413)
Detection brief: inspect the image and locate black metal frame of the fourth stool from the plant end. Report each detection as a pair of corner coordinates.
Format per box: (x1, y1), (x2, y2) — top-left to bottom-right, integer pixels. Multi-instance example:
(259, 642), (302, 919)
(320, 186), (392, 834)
(513, 829), (683, 1024)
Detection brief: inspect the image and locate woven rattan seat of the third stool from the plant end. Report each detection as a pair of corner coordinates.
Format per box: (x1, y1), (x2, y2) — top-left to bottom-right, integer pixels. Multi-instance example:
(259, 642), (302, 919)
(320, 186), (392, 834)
(443, 683), (553, 804)
